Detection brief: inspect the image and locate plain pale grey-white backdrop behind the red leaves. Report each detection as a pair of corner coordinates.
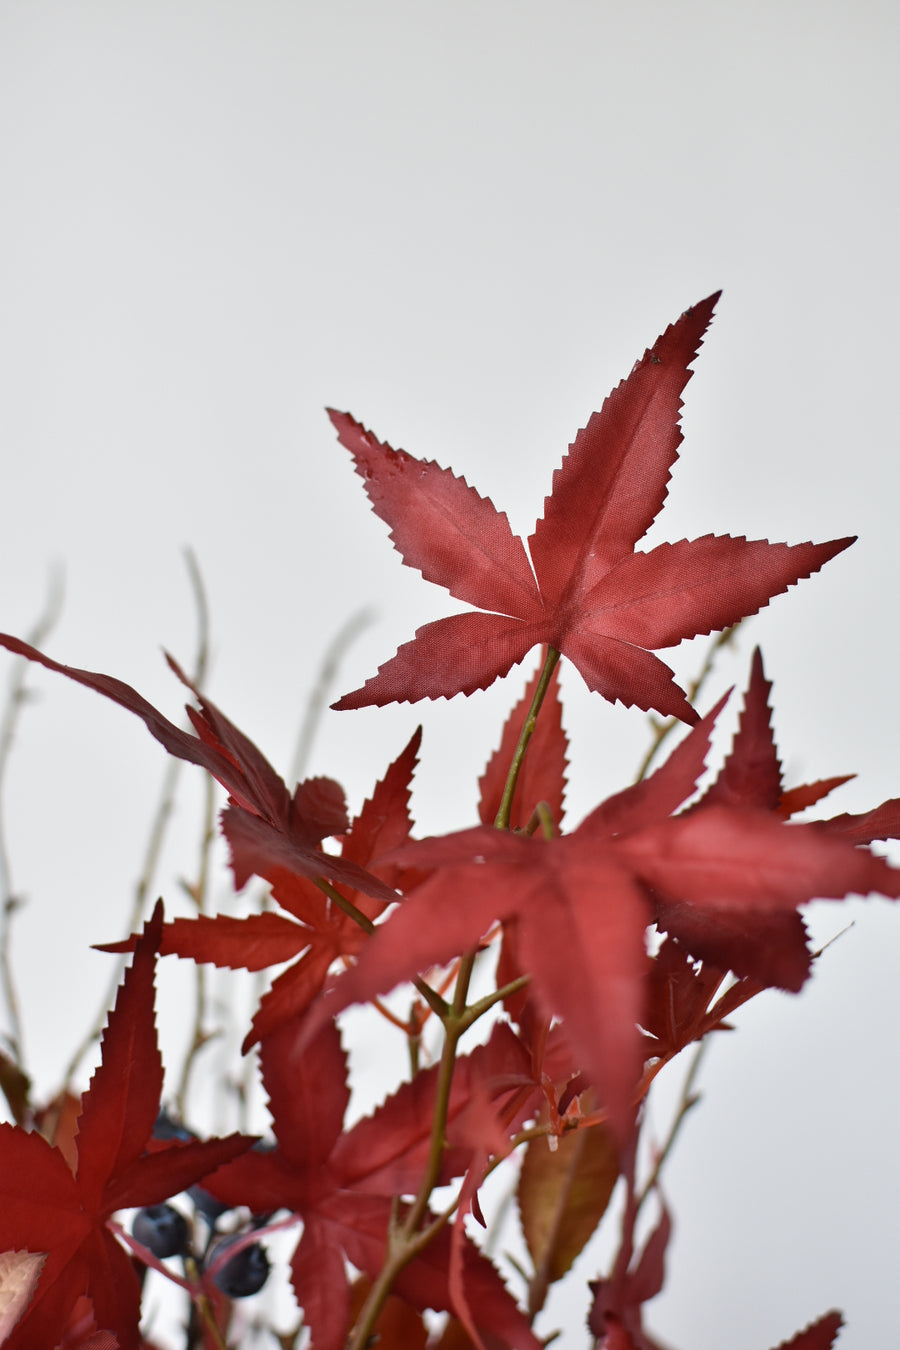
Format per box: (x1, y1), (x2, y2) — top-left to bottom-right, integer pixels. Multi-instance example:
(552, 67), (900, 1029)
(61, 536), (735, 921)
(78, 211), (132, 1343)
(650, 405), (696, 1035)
(0, 0), (900, 1350)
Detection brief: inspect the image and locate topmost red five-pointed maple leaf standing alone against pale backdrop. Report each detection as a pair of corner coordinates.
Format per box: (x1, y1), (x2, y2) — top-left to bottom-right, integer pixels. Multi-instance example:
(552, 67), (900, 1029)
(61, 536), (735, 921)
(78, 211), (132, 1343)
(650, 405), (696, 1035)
(329, 293), (853, 722)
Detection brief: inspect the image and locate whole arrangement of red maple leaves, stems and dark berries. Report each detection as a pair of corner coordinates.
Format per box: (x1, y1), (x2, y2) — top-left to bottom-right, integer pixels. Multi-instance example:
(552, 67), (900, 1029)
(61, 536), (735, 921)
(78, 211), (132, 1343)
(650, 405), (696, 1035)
(0, 296), (900, 1350)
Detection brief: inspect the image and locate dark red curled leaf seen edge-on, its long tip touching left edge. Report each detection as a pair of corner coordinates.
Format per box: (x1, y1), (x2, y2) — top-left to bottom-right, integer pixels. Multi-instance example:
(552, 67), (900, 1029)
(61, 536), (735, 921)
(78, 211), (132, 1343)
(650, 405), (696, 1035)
(0, 633), (395, 902)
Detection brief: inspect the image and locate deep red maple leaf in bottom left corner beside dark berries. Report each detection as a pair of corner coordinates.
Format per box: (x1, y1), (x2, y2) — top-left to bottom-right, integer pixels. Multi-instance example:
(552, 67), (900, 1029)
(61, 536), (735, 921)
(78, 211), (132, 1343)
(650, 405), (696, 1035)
(0, 905), (254, 1350)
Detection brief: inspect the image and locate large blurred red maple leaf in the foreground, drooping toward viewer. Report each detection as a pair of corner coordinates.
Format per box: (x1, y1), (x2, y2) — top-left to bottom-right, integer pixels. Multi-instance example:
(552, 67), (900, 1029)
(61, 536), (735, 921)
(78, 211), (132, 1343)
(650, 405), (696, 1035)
(309, 788), (900, 1134)
